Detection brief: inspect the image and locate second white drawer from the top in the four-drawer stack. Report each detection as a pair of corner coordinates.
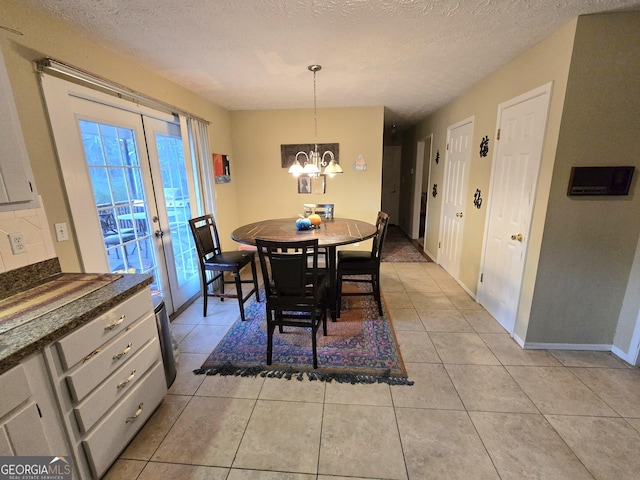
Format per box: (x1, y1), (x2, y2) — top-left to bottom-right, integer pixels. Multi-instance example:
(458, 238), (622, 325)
(67, 313), (158, 402)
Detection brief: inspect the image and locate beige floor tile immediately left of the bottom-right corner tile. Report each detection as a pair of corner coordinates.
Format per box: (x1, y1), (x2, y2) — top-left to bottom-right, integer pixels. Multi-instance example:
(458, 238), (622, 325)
(469, 412), (593, 480)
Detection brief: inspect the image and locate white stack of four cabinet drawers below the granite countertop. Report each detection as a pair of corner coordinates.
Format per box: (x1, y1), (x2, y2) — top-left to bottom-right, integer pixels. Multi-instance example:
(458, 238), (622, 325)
(44, 288), (167, 479)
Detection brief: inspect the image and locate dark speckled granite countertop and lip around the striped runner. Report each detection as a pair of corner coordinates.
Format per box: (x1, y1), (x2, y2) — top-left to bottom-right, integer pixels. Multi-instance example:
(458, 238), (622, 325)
(0, 259), (153, 374)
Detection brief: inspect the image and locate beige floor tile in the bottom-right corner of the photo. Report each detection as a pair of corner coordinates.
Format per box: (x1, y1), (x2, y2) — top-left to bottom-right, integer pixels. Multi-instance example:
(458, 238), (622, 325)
(547, 415), (640, 480)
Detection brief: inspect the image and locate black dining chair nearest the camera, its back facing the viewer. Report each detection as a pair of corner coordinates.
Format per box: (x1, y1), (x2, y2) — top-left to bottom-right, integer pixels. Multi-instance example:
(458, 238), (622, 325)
(256, 238), (329, 368)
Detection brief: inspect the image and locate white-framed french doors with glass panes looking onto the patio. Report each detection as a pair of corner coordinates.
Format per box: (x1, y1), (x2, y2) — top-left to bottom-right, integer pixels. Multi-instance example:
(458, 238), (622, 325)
(42, 75), (199, 313)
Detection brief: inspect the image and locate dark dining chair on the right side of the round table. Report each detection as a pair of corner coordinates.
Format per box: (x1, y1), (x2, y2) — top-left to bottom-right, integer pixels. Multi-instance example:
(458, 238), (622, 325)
(336, 212), (389, 317)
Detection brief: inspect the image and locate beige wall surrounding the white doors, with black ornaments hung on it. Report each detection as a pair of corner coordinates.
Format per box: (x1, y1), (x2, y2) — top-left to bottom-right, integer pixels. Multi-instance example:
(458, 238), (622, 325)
(410, 21), (576, 304)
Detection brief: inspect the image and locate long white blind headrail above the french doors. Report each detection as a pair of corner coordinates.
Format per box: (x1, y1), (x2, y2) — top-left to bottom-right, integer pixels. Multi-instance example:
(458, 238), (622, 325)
(36, 57), (211, 125)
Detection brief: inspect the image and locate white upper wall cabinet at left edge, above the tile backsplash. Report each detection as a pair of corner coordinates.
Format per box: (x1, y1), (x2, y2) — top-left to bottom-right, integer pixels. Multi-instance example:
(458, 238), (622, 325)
(0, 50), (38, 211)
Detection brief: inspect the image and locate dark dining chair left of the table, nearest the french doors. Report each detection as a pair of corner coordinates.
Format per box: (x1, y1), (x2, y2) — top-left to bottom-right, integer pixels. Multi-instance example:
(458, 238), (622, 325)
(189, 214), (260, 321)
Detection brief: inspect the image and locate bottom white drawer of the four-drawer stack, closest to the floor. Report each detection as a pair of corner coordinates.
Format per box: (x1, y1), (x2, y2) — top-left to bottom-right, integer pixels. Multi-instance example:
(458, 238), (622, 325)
(82, 363), (167, 478)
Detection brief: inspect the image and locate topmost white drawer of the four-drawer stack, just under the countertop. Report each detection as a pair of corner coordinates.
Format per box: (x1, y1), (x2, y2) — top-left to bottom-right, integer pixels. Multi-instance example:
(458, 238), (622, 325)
(56, 289), (153, 370)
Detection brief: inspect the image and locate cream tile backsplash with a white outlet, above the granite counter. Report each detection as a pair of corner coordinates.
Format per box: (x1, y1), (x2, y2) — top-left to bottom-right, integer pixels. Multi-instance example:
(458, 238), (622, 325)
(0, 199), (56, 272)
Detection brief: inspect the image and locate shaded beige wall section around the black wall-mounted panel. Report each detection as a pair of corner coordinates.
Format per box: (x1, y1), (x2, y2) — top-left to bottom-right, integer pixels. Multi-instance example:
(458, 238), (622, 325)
(526, 12), (640, 345)
